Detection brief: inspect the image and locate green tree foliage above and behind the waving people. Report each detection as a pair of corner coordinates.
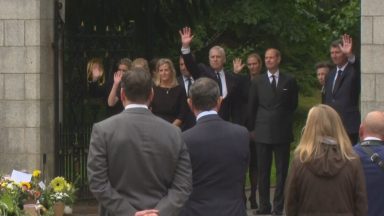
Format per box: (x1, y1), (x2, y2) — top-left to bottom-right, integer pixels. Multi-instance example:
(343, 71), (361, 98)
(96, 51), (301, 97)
(164, 0), (360, 96)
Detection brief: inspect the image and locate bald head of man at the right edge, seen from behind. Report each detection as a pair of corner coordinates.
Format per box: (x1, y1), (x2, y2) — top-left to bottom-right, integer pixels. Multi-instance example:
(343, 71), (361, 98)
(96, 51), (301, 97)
(360, 111), (384, 140)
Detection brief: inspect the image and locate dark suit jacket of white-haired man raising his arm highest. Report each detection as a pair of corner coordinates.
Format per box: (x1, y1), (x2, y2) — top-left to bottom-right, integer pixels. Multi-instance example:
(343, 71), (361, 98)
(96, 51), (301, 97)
(183, 53), (241, 121)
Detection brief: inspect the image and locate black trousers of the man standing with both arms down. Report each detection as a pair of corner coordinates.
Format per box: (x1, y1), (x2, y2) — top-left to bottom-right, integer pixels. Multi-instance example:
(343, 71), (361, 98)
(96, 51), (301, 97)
(256, 143), (290, 212)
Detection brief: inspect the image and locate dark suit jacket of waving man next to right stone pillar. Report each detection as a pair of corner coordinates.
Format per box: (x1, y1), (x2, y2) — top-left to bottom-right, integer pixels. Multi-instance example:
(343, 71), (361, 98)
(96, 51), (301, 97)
(325, 59), (360, 134)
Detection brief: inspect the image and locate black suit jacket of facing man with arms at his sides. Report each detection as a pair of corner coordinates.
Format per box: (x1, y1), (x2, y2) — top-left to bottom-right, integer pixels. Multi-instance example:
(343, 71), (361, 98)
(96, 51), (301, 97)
(248, 71), (298, 144)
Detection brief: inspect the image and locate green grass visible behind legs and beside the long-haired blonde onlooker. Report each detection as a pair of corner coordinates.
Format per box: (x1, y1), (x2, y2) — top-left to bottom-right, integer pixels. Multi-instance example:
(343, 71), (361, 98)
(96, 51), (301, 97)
(246, 92), (321, 186)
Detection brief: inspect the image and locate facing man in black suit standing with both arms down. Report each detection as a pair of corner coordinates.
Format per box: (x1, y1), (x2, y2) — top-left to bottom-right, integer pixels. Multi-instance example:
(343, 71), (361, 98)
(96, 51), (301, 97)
(248, 48), (298, 215)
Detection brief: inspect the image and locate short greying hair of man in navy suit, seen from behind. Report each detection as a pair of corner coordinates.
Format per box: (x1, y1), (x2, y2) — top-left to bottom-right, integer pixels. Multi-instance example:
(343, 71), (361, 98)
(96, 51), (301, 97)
(189, 78), (220, 111)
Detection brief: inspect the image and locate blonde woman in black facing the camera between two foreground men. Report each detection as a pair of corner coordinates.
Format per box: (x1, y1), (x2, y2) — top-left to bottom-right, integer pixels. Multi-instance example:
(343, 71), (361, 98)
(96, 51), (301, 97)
(151, 58), (188, 127)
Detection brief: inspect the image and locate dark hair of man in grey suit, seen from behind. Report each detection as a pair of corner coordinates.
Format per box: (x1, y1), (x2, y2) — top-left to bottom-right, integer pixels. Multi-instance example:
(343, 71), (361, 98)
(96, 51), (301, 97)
(121, 68), (152, 103)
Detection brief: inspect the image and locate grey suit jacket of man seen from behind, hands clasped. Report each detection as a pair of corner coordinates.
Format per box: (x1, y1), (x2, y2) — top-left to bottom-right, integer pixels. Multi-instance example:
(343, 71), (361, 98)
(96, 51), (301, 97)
(87, 108), (192, 216)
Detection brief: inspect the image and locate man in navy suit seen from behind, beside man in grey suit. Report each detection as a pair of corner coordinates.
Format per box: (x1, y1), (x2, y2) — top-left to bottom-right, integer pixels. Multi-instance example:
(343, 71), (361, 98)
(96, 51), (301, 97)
(181, 78), (249, 216)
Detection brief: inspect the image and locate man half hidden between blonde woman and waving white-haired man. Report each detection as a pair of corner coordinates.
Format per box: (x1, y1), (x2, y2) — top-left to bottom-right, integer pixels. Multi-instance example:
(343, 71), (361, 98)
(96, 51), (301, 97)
(177, 56), (196, 131)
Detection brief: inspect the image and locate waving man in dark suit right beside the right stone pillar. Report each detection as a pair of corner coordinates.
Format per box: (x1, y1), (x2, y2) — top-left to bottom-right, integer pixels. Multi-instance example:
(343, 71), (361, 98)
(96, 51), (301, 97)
(324, 34), (361, 145)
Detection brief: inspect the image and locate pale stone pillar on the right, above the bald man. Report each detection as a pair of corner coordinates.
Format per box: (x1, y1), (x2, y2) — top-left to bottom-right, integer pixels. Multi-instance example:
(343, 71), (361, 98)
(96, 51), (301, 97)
(361, 0), (384, 117)
